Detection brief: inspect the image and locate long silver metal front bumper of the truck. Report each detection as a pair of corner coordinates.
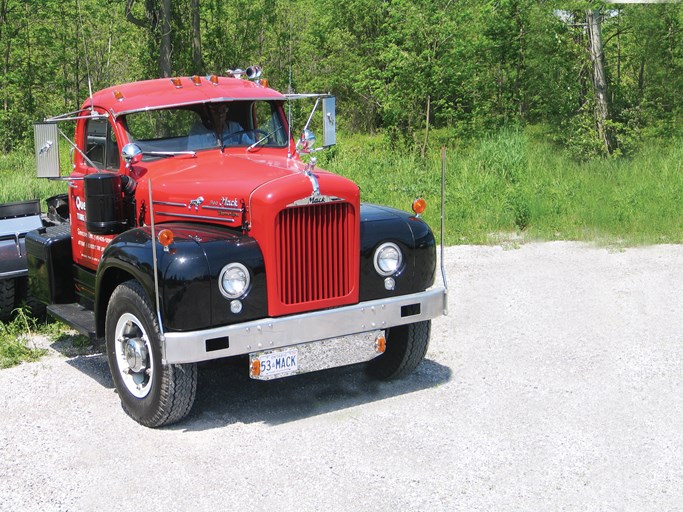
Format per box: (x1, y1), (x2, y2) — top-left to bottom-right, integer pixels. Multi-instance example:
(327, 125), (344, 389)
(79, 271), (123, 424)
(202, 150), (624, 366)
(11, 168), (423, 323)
(163, 288), (447, 364)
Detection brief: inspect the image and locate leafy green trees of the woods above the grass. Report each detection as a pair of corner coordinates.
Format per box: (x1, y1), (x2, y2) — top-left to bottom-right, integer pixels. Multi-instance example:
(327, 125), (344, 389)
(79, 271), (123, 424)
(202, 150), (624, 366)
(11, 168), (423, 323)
(0, 0), (683, 160)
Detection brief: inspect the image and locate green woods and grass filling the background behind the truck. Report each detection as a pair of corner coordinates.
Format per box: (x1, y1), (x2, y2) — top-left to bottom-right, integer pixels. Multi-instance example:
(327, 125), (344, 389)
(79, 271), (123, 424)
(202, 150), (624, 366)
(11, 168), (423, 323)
(0, 0), (683, 243)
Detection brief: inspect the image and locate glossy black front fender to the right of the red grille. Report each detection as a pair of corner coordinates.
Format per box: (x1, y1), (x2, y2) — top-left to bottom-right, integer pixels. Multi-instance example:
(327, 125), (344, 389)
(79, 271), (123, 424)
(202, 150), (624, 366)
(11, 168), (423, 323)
(360, 203), (436, 301)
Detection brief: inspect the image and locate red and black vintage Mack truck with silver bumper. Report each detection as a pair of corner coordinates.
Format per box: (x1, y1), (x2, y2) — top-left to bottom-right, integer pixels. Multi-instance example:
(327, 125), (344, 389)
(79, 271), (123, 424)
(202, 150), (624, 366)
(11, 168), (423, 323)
(5, 67), (447, 427)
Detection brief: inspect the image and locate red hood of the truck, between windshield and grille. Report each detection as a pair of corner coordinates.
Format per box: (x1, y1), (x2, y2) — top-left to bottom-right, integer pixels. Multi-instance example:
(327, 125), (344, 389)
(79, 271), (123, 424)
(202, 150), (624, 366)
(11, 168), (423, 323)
(135, 150), (358, 227)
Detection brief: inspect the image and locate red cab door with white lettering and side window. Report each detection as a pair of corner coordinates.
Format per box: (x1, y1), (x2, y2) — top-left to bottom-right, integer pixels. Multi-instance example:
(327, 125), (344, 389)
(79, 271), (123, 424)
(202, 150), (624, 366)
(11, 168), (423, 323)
(69, 111), (121, 270)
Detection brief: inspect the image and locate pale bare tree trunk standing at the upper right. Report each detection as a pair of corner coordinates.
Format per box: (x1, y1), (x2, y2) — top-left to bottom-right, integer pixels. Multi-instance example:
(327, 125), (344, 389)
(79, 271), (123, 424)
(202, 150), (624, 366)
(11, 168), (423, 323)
(586, 9), (615, 154)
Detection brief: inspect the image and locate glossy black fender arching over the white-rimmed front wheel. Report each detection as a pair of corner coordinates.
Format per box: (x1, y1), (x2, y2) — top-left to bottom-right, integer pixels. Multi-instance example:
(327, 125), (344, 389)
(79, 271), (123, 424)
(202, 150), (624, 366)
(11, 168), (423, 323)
(95, 223), (267, 336)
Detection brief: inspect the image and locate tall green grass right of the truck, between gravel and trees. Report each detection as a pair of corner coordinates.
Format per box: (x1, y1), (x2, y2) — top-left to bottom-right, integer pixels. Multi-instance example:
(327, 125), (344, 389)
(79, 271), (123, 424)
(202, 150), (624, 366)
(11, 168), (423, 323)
(320, 129), (683, 245)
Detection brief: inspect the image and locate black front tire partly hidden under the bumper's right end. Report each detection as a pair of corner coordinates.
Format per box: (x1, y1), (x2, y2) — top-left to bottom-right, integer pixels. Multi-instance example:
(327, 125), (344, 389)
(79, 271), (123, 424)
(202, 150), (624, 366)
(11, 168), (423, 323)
(368, 320), (432, 380)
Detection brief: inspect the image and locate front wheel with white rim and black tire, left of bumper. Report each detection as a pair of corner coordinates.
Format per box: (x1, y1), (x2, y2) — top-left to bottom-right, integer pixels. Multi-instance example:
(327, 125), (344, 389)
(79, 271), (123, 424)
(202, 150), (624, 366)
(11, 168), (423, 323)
(105, 281), (197, 427)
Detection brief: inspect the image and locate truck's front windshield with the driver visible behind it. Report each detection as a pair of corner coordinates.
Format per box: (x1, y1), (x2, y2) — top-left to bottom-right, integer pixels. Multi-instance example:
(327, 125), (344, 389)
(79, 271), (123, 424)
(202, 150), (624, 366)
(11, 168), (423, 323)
(124, 101), (288, 153)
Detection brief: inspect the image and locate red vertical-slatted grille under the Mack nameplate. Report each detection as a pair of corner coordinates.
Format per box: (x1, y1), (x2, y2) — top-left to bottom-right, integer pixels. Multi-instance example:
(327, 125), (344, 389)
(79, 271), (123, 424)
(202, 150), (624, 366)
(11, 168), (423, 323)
(276, 203), (352, 305)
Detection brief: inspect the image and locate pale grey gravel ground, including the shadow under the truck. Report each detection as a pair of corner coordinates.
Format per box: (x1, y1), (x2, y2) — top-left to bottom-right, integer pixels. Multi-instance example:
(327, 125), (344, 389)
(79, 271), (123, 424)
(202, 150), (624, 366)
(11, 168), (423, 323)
(0, 242), (683, 512)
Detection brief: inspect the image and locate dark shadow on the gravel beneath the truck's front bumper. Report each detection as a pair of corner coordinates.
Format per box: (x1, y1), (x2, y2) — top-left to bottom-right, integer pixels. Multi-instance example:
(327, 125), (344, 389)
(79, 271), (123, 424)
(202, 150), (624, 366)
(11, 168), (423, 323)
(179, 359), (452, 431)
